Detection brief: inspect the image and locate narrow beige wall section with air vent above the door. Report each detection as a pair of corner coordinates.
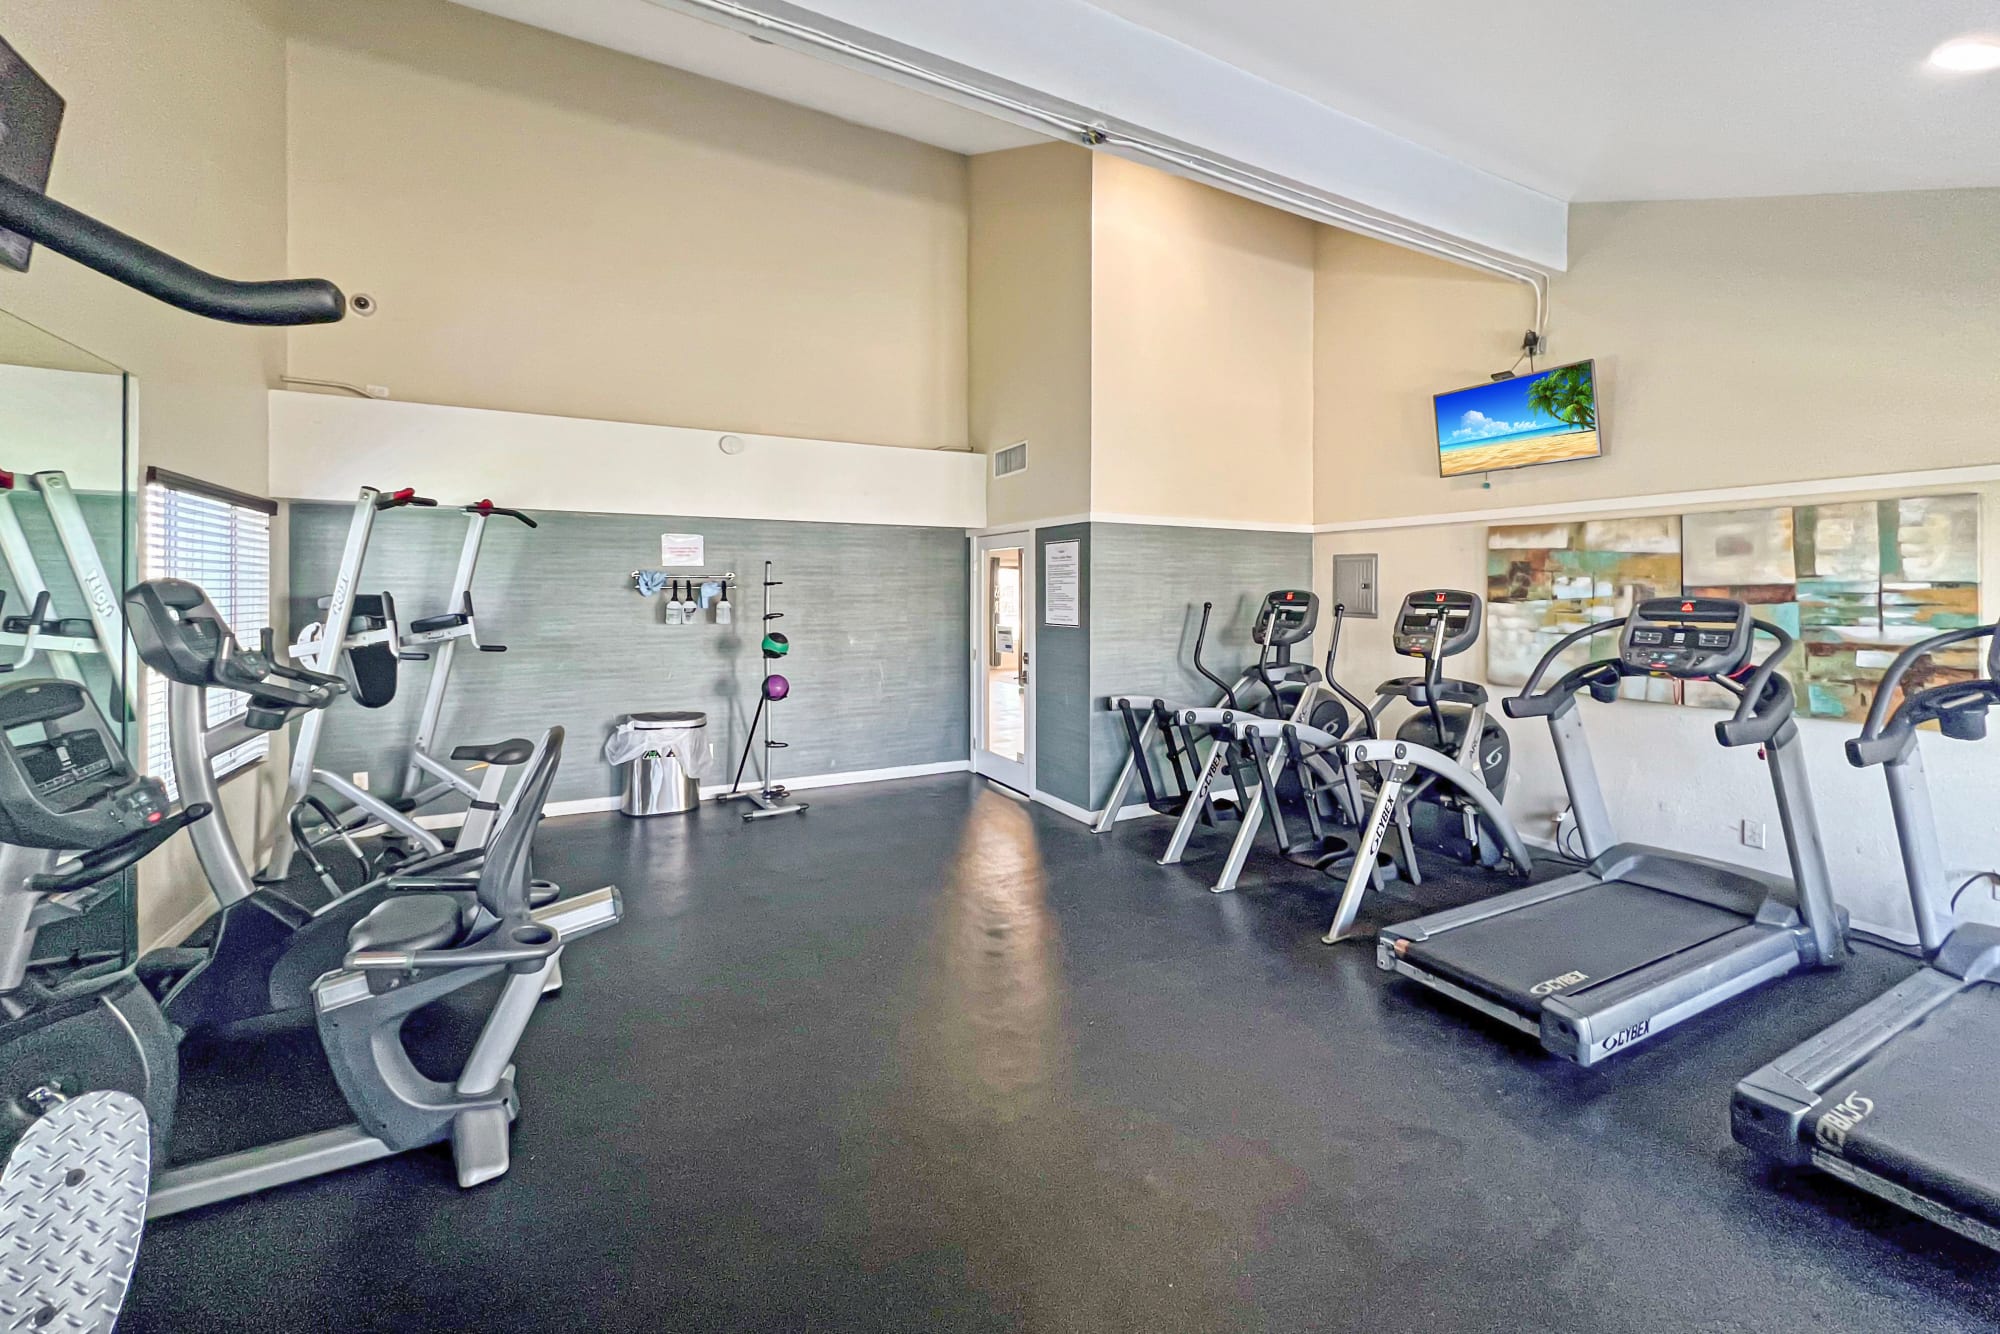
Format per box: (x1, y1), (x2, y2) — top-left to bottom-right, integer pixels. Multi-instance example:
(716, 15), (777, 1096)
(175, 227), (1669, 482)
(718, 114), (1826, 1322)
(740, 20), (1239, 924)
(968, 144), (1090, 526)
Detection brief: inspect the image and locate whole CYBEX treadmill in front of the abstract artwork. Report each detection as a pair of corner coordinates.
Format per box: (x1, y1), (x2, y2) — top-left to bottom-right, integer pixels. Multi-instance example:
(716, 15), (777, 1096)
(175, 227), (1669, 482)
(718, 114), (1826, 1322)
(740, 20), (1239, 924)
(1376, 598), (1846, 1066)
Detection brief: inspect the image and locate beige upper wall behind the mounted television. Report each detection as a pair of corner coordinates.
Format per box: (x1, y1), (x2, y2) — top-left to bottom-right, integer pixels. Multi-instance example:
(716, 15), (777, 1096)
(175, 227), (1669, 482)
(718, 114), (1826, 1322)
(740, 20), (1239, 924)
(1314, 190), (2000, 522)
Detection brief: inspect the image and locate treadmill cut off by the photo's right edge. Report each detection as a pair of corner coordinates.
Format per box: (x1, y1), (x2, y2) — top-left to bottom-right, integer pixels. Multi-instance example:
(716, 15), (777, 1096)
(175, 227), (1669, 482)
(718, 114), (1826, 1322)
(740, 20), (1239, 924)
(1730, 626), (2000, 1250)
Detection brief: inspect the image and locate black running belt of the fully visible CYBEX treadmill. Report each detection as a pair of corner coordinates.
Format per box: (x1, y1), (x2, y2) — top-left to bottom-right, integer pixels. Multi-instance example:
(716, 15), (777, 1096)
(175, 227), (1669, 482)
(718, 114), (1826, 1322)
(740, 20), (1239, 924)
(1404, 880), (1748, 1014)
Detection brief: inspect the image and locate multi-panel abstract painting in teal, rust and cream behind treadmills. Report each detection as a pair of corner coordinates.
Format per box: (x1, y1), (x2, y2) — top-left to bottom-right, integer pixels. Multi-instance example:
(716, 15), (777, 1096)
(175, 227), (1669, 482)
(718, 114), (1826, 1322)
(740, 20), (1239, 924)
(1486, 496), (1980, 722)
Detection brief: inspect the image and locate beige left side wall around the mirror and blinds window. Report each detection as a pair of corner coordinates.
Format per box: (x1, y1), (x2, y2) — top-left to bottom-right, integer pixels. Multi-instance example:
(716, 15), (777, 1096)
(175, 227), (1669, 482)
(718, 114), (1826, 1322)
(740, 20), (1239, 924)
(0, 0), (286, 942)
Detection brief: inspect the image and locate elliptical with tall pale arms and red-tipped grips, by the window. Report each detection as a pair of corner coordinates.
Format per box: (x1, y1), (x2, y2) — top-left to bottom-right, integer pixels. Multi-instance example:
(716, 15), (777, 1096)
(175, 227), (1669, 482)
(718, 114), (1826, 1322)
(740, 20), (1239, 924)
(270, 486), (534, 896)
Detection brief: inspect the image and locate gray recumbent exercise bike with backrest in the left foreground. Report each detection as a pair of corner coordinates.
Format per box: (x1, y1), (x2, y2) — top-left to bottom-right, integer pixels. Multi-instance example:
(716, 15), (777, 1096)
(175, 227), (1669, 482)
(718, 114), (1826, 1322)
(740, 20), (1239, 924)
(0, 680), (620, 1218)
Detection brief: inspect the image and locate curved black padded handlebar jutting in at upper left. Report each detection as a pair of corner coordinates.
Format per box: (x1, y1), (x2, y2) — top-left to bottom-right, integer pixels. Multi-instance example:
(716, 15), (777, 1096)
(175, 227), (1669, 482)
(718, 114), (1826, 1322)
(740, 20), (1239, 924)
(0, 176), (348, 326)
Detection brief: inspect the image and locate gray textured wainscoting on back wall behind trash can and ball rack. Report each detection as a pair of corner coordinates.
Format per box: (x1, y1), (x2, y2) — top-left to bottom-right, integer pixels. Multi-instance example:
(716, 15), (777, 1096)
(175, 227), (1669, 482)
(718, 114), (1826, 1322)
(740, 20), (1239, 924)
(290, 504), (970, 810)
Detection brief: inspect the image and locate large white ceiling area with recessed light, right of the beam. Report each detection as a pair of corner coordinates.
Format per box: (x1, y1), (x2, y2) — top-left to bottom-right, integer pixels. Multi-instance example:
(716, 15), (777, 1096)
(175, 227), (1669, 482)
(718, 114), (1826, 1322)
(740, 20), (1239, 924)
(1092, 0), (2000, 200)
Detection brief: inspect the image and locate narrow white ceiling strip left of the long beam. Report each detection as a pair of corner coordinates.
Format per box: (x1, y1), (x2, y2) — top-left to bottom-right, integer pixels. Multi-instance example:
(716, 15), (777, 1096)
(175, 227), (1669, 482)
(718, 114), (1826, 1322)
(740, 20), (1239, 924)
(458, 0), (1044, 154)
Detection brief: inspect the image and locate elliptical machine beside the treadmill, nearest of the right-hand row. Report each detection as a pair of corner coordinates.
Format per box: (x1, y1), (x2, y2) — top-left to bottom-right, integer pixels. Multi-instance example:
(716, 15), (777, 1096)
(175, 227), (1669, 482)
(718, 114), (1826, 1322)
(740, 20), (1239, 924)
(1322, 588), (1534, 944)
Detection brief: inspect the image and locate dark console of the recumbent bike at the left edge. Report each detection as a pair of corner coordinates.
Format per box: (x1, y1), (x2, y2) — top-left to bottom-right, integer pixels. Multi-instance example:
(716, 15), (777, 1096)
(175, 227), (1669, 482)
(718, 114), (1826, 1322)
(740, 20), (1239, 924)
(0, 680), (168, 852)
